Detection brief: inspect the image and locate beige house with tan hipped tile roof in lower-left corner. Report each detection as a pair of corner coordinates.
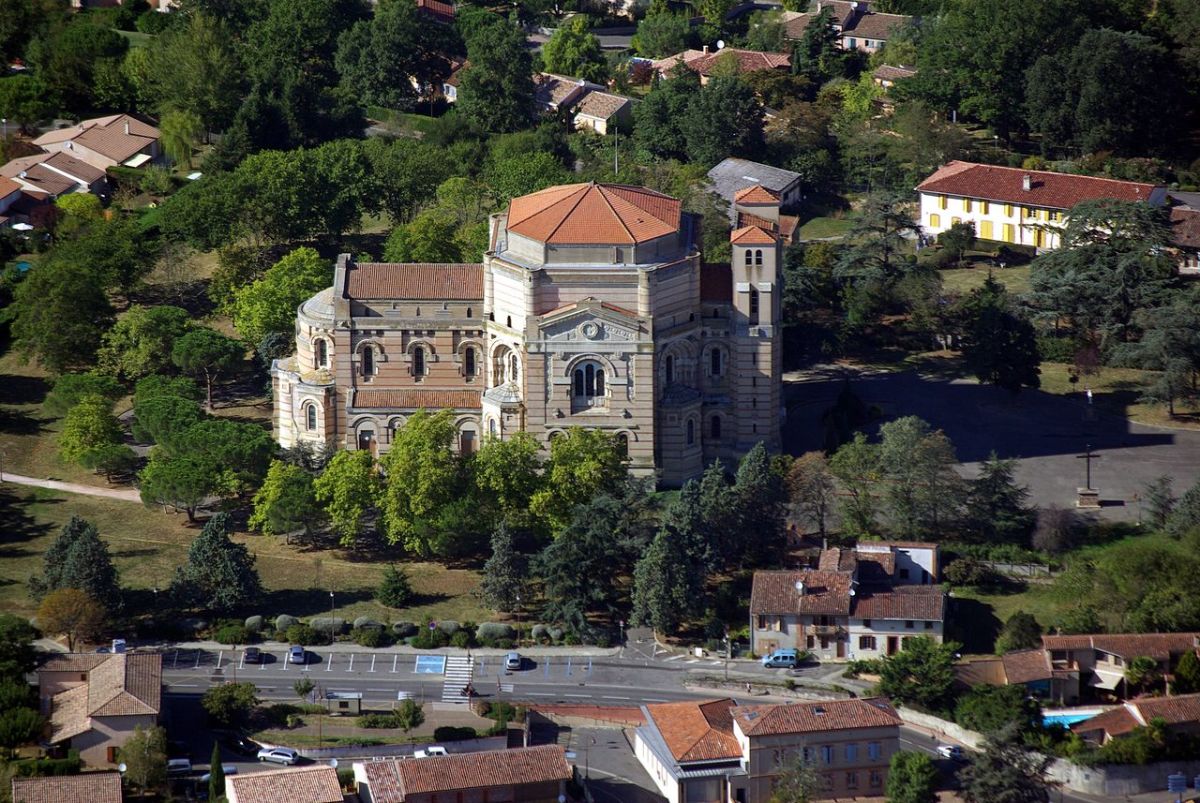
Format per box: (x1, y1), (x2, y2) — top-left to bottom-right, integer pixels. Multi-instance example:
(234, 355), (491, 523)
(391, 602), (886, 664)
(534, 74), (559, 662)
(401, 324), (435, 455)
(37, 653), (162, 767)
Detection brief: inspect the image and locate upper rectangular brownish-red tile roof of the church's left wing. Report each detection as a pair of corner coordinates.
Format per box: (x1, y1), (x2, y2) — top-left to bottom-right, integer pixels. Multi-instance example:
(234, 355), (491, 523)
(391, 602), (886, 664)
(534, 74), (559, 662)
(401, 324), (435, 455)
(344, 262), (484, 302)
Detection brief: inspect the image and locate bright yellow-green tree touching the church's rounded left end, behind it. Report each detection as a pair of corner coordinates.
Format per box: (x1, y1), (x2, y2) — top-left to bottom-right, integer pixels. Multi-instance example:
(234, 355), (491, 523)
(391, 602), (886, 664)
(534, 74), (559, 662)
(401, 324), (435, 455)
(233, 248), (332, 343)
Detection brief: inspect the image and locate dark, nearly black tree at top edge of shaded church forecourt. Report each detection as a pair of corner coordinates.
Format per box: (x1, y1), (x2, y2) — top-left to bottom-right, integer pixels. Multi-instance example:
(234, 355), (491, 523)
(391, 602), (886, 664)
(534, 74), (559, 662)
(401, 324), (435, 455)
(962, 274), (1042, 394)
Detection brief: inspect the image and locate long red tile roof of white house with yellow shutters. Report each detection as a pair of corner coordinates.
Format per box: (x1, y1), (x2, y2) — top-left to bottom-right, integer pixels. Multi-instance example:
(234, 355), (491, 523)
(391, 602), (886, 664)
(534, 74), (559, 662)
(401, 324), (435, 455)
(917, 161), (1157, 210)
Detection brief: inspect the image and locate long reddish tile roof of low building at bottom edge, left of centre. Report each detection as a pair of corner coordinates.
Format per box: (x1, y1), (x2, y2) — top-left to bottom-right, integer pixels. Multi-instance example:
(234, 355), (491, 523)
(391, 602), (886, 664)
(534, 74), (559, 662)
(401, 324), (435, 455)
(364, 744), (571, 803)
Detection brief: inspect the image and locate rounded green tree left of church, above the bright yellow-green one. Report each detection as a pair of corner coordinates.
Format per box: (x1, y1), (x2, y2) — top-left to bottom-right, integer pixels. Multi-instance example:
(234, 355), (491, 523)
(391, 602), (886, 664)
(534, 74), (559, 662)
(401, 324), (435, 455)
(97, 305), (192, 380)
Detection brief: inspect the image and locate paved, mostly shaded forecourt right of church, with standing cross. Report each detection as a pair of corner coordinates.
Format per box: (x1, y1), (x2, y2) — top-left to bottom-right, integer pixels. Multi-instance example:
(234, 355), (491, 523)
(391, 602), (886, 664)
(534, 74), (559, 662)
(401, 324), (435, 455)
(784, 366), (1200, 521)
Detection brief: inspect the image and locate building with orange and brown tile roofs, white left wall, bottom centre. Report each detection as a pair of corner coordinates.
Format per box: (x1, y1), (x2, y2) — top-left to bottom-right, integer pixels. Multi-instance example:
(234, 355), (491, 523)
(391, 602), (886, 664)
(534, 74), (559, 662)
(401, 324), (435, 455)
(634, 699), (900, 803)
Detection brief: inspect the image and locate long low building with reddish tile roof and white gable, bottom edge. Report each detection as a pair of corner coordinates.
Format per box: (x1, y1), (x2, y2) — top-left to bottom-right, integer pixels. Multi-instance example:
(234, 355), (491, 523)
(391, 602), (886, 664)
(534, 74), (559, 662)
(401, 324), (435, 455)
(354, 744), (574, 803)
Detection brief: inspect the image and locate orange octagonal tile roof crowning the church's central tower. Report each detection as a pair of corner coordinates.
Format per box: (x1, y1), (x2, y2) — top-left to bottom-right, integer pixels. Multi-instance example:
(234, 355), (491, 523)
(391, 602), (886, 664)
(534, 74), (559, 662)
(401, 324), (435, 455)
(508, 182), (680, 245)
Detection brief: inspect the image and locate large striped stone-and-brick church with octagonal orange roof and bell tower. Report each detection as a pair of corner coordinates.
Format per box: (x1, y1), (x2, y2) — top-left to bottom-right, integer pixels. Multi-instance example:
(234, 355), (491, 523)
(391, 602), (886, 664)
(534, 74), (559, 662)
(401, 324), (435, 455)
(272, 184), (780, 485)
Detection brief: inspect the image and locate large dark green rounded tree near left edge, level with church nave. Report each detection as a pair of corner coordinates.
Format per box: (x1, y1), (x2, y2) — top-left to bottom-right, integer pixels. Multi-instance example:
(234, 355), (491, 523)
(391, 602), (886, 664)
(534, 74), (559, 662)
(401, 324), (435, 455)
(7, 248), (113, 373)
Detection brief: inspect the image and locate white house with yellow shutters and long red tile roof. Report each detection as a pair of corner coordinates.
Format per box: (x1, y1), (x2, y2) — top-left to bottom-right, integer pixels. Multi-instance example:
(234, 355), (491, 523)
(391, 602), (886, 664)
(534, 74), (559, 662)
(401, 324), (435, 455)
(917, 161), (1166, 251)
